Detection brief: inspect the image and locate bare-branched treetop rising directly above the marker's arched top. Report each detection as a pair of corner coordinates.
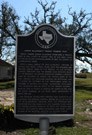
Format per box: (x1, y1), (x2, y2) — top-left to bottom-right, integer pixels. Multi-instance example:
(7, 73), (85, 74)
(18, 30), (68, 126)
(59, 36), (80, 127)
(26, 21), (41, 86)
(24, 0), (65, 32)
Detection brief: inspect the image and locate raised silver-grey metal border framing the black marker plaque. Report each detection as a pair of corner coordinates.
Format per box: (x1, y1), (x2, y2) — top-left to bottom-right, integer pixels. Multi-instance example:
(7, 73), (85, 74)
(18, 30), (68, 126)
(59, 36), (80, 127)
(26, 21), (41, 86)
(14, 24), (76, 123)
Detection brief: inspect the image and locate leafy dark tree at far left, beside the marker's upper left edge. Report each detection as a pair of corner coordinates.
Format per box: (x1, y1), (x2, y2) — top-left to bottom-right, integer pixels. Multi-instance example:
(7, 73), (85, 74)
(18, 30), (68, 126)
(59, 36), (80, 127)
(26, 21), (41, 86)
(0, 2), (21, 59)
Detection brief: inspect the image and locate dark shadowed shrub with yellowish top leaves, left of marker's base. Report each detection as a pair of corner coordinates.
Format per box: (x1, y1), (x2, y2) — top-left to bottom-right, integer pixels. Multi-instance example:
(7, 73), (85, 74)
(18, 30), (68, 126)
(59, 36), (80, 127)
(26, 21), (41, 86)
(0, 104), (38, 130)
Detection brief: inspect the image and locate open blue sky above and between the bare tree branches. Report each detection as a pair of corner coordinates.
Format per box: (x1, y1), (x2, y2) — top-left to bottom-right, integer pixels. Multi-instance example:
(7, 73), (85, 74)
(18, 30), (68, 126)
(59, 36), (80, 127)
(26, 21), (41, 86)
(0, 0), (92, 69)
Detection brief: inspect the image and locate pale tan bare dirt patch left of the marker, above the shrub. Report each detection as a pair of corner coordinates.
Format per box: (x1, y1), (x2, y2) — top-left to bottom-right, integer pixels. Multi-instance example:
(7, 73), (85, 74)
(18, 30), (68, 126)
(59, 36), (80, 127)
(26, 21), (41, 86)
(0, 89), (14, 106)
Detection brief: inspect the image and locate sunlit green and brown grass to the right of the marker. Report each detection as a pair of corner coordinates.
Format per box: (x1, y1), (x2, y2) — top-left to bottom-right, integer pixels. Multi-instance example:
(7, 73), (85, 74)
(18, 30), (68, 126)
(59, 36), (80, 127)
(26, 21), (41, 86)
(74, 75), (92, 135)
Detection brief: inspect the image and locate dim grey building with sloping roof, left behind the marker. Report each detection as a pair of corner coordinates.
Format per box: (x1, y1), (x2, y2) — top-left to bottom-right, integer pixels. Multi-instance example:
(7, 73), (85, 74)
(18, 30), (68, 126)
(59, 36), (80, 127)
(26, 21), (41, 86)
(0, 59), (14, 81)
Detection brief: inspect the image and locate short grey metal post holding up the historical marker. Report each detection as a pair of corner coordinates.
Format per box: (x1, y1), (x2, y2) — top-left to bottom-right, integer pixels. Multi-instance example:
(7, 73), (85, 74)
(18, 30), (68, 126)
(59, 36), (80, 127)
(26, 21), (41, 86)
(40, 118), (49, 135)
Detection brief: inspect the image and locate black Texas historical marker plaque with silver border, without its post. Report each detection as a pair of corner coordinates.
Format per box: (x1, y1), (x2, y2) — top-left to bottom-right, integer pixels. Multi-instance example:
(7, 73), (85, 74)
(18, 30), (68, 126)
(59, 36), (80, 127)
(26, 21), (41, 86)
(15, 24), (74, 122)
